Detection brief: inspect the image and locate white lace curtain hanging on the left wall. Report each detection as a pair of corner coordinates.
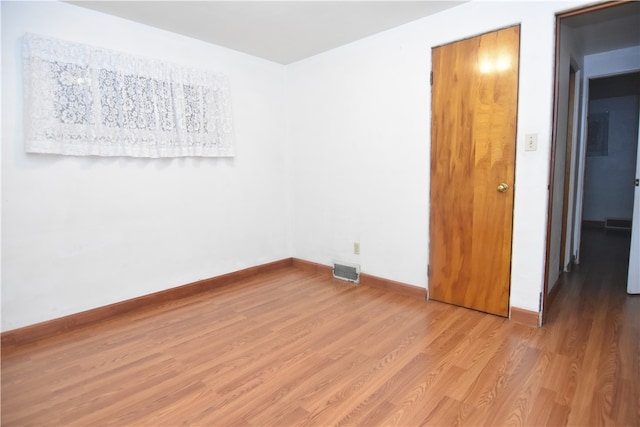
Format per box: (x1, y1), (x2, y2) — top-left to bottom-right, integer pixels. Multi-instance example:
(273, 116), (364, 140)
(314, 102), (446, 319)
(23, 34), (238, 157)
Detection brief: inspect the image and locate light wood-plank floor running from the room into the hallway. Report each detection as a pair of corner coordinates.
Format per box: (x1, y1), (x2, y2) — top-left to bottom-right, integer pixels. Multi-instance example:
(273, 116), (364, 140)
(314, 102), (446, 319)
(2, 231), (640, 426)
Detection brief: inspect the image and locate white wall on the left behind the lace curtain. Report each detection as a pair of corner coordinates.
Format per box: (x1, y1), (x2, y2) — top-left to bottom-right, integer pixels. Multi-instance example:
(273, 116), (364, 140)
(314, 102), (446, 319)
(2, 1), (291, 331)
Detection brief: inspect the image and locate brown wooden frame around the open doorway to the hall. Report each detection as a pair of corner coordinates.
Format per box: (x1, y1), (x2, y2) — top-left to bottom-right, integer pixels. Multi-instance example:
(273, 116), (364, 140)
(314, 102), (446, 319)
(538, 0), (640, 326)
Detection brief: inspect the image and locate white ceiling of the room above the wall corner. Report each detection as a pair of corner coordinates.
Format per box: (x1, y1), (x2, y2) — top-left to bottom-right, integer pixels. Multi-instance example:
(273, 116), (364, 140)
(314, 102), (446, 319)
(68, 0), (468, 64)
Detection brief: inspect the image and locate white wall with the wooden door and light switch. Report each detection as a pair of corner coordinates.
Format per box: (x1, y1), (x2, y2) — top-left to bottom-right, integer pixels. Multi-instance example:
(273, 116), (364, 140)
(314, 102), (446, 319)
(288, 2), (584, 311)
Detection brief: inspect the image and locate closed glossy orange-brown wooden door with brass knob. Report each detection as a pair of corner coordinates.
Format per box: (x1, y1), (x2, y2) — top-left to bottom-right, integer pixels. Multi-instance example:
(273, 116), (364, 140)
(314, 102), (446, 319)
(429, 26), (520, 316)
